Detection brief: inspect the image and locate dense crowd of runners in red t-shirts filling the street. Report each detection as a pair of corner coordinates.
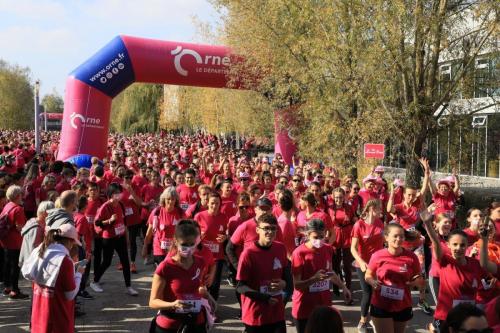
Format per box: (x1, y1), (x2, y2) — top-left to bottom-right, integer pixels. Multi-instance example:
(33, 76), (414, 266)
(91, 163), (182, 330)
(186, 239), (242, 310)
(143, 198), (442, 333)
(0, 132), (500, 333)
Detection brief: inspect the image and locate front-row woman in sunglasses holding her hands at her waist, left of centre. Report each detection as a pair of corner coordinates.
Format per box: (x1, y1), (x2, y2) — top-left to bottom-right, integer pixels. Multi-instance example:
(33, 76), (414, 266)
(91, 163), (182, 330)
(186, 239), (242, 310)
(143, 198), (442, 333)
(149, 221), (208, 333)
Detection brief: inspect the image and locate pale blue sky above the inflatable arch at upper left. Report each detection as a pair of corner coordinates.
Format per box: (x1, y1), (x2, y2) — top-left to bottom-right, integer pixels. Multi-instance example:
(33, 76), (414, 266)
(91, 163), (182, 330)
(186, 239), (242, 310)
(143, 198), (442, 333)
(0, 0), (223, 97)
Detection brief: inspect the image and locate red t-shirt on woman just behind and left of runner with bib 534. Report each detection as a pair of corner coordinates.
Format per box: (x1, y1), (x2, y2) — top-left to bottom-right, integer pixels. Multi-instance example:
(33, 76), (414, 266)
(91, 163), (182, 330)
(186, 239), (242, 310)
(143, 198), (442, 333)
(352, 219), (385, 265)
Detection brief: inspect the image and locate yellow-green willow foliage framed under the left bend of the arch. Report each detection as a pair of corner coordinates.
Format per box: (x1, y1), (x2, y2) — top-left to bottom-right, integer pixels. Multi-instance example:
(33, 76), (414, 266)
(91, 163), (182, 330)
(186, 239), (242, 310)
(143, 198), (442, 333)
(111, 83), (163, 133)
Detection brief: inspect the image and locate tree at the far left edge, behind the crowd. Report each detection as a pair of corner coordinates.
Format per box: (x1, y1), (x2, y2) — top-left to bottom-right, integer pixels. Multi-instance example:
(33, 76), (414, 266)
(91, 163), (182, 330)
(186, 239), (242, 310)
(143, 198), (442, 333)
(0, 59), (34, 129)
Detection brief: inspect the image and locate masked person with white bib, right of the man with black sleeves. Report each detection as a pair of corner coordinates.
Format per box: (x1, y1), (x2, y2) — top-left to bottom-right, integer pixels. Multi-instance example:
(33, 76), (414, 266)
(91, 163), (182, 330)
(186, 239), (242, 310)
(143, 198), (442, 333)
(292, 219), (351, 333)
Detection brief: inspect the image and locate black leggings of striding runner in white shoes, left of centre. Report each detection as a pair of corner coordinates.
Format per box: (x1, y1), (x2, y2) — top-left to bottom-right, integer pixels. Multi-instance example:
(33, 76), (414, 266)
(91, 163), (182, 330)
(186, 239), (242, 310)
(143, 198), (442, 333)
(94, 236), (130, 287)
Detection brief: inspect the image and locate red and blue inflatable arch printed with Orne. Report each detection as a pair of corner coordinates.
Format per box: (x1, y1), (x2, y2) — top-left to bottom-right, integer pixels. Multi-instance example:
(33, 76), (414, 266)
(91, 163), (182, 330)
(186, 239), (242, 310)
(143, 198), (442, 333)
(57, 36), (291, 167)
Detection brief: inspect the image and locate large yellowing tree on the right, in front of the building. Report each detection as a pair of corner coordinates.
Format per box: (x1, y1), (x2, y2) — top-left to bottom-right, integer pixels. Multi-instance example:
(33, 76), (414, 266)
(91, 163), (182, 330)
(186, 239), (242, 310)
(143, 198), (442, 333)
(212, 0), (499, 184)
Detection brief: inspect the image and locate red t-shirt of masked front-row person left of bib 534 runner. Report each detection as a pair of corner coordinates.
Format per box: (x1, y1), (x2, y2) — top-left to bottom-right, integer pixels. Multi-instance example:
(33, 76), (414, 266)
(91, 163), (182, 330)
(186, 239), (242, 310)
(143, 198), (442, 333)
(292, 244), (334, 319)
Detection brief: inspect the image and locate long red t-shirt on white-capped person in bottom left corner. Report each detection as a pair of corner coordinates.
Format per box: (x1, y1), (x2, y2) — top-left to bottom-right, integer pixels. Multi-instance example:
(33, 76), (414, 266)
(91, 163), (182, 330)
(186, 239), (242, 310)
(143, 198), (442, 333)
(31, 257), (76, 333)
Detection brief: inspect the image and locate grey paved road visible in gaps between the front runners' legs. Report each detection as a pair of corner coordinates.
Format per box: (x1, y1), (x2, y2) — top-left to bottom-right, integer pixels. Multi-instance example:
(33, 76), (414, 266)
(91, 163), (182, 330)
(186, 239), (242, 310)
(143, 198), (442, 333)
(0, 256), (431, 333)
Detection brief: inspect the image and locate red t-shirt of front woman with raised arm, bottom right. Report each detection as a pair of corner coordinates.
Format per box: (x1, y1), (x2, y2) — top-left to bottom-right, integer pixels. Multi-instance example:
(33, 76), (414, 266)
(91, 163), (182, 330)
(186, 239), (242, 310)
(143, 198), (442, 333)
(434, 254), (485, 320)
